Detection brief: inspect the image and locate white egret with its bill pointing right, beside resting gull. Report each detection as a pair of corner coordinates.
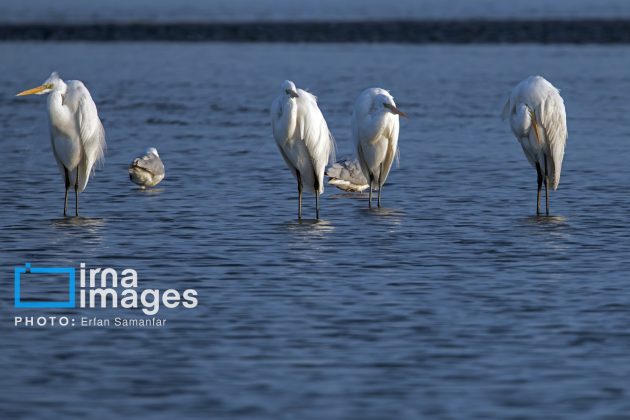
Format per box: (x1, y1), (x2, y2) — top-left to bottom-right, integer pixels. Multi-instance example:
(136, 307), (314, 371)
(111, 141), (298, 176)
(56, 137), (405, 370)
(352, 88), (406, 207)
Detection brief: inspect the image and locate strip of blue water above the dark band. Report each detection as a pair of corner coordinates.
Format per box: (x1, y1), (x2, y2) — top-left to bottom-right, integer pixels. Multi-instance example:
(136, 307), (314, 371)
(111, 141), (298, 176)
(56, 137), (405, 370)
(0, 0), (630, 23)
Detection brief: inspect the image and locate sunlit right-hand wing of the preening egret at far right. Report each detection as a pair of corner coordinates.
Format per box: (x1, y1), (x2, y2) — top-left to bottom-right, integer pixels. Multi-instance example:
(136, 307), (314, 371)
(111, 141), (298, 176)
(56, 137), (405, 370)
(536, 92), (568, 190)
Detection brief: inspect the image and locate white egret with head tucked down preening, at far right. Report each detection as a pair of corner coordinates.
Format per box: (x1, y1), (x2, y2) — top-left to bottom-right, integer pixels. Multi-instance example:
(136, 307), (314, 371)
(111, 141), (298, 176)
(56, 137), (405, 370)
(503, 76), (568, 216)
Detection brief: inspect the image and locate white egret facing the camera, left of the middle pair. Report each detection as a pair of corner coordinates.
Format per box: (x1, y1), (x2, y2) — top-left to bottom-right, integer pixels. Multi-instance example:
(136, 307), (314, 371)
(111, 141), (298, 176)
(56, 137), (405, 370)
(271, 80), (335, 219)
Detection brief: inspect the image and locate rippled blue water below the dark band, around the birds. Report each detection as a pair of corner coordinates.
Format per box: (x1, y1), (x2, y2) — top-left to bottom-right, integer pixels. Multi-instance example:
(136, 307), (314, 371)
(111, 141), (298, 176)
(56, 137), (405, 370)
(0, 43), (630, 419)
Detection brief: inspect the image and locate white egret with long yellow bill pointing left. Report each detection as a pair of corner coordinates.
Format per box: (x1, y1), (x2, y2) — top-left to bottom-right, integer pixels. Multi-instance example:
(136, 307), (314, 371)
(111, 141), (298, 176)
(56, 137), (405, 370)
(17, 73), (105, 216)
